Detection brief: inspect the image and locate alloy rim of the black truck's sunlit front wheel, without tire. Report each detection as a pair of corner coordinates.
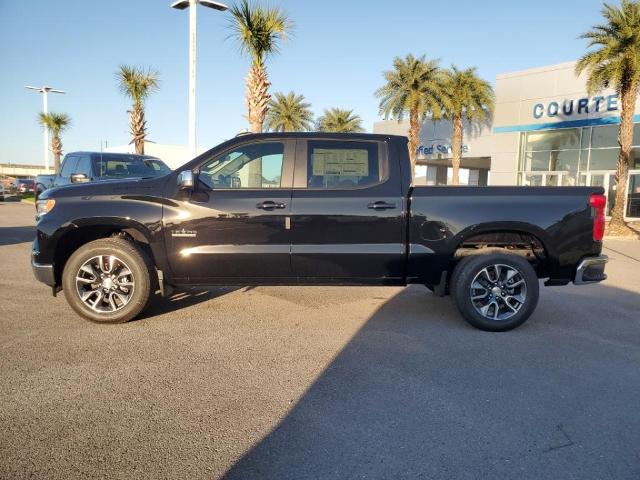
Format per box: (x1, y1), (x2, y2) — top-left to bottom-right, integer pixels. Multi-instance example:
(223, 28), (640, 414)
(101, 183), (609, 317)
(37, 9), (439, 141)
(76, 255), (135, 313)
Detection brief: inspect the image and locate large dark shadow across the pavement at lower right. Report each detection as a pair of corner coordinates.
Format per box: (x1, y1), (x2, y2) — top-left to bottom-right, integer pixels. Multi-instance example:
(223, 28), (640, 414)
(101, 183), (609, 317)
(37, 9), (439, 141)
(224, 285), (640, 480)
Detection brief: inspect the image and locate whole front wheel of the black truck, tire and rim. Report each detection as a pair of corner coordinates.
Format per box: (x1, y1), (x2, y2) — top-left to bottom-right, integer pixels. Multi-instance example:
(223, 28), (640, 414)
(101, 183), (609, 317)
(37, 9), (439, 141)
(62, 238), (154, 323)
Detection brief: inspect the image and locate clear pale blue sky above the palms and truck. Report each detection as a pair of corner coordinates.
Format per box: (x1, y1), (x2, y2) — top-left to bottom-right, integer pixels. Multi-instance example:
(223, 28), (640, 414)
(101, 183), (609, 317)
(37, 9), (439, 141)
(0, 0), (602, 163)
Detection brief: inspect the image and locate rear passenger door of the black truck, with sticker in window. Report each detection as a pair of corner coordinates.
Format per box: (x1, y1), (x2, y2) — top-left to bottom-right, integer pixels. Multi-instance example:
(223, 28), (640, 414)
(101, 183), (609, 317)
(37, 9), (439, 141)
(291, 138), (405, 283)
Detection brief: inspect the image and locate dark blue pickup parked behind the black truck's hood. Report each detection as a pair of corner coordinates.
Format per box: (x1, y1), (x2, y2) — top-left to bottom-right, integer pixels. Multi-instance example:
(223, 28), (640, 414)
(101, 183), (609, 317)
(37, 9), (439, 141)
(35, 152), (171, 199)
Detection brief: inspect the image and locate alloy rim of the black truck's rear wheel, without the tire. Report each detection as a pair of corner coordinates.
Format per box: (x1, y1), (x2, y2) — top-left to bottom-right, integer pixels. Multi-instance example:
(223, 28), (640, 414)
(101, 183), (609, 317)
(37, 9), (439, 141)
(469, 264), (527, 321)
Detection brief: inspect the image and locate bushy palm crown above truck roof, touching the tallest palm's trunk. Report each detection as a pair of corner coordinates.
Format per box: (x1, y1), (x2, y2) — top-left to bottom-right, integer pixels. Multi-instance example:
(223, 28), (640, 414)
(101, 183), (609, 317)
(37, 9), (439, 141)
(266, 92), (313, 132)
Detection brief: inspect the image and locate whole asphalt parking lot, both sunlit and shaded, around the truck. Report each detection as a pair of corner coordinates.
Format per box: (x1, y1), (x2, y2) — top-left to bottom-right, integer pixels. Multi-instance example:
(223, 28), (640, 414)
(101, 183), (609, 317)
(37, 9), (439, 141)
(0, 203), (640, 480)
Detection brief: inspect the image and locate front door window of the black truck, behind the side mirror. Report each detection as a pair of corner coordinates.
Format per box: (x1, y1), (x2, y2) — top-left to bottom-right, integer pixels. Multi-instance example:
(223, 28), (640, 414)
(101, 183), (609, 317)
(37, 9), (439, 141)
(198, 142), (284, 190)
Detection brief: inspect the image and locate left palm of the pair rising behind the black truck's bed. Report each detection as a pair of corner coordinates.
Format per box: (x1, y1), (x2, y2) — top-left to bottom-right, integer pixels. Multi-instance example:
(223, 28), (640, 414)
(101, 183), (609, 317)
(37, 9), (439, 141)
(376, 54), (446, 174)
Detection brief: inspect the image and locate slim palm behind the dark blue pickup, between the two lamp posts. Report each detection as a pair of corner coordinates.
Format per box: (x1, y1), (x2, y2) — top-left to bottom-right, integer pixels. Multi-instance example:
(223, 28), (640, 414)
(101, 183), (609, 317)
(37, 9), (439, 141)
(116, 65), (159, 155)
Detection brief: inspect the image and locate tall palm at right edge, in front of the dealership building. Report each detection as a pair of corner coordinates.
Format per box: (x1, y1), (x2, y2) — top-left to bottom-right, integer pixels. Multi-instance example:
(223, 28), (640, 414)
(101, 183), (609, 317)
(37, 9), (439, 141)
(576, 0), (640, 235)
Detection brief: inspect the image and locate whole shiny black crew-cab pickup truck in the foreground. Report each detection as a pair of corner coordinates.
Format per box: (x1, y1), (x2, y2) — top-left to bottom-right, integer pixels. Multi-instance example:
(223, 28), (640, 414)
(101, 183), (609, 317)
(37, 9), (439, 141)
(32, 133), (607, 331)
